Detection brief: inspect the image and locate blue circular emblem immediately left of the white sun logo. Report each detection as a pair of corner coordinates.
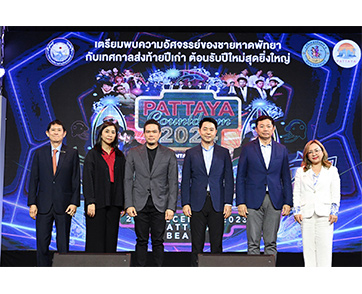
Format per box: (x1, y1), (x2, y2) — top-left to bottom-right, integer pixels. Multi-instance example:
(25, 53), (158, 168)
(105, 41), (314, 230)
(302, 40), (330, 67)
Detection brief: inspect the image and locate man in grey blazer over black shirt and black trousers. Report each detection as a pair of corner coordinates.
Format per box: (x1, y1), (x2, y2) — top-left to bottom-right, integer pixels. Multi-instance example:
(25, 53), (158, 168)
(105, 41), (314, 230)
(124, 119), (178, 266)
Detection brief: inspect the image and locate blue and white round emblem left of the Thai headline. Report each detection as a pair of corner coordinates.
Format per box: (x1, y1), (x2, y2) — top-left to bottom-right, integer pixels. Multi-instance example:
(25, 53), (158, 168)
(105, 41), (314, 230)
(45, 38), (74, 66)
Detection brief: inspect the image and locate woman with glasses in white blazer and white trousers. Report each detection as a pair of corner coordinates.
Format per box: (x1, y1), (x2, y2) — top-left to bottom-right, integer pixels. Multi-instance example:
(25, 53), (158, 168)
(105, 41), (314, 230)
(293, 140), (341, 267)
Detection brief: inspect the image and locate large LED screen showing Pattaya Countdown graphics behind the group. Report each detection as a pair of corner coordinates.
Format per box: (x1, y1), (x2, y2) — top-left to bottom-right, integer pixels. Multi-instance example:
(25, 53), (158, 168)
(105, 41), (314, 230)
(2, 28), (362, 252)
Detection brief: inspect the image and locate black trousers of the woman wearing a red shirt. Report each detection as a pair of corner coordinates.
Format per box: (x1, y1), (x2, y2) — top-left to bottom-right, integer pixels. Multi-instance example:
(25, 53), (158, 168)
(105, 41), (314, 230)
(85, 206), (121, 253)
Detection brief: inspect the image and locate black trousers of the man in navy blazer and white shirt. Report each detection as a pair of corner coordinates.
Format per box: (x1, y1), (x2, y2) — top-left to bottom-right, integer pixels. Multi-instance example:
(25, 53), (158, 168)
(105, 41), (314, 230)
(190, 196), (224, 266)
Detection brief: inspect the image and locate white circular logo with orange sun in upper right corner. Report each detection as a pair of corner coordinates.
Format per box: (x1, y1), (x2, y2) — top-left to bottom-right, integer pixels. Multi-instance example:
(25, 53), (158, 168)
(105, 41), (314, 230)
(333, 40), (361, 68)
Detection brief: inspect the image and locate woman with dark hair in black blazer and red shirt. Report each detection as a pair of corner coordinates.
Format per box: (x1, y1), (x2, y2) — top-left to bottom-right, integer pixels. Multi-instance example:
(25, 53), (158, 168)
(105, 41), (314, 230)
(83, 122), (126, 253)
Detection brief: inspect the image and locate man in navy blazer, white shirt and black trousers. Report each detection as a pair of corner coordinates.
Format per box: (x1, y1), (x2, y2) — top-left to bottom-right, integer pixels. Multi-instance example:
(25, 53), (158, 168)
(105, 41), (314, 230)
(181, 117), (234, 266)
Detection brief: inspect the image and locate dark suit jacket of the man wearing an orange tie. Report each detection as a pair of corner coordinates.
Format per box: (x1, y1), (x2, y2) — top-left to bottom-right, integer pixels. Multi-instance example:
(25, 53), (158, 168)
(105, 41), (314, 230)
(28, 144), (80, 214)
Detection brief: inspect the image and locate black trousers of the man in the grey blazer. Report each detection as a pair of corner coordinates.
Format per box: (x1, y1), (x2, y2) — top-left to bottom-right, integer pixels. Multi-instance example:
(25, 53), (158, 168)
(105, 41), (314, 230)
(134, 196), (166, 266)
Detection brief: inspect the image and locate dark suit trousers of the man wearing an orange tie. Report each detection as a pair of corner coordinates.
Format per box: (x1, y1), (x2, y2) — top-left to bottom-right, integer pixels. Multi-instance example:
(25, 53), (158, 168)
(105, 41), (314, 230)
(36, 208), (72, 266)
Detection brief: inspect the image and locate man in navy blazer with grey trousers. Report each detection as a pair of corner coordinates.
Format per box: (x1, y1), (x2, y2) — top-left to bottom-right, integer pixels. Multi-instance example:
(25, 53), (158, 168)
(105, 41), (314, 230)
(236, 115), (293, 256)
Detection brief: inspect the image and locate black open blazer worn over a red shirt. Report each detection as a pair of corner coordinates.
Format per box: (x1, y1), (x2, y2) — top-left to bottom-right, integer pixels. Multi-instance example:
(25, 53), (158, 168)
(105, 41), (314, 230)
(83, 147), (126, 210)
